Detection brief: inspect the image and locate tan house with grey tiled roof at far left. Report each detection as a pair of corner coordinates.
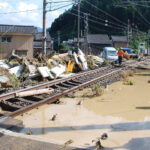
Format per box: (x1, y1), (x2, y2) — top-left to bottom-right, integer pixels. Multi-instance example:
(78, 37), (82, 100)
(0, 25), (37, 58)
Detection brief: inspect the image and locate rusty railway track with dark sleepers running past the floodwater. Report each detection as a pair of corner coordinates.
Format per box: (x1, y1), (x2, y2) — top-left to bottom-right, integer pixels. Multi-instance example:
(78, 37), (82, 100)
(0, 58), (148, 117)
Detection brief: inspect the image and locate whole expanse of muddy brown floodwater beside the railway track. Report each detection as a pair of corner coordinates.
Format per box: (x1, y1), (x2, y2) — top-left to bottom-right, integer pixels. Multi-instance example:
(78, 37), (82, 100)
(17, 71), (150, 150)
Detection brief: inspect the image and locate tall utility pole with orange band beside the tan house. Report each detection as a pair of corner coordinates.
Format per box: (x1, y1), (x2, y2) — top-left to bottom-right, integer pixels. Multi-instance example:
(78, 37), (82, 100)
(42, 0), (47, 56)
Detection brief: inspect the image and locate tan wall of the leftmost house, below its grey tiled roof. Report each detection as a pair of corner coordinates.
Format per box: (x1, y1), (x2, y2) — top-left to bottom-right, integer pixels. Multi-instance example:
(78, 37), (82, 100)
(0, 34), (34, 58)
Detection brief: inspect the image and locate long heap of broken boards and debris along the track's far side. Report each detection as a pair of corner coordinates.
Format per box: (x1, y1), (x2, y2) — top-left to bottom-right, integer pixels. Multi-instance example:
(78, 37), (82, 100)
(0, 49), (106, 90)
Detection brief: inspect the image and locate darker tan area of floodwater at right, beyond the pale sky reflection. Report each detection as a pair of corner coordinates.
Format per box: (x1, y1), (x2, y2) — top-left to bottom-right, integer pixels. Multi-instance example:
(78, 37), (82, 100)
(84, 71), (150, 121)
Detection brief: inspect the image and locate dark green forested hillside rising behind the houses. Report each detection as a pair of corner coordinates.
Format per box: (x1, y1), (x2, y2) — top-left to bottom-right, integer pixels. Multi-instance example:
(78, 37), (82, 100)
(49, 0), (150, 44)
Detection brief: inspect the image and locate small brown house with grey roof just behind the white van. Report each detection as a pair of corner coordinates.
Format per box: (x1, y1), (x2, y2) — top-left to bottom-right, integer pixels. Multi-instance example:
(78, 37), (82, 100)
(111, 35), (128, 48)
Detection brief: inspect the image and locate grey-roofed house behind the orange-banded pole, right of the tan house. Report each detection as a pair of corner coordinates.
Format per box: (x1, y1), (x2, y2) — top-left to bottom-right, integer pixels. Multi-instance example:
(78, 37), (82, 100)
(34, 32), (52, 53)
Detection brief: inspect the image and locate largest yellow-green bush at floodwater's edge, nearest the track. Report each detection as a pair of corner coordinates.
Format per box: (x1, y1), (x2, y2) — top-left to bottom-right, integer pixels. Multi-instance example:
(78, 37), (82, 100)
(92, 83), (104, 96)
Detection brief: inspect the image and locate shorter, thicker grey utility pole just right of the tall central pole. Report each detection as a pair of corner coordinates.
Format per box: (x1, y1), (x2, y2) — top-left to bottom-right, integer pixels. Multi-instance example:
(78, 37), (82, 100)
(84, 13), (89, 54)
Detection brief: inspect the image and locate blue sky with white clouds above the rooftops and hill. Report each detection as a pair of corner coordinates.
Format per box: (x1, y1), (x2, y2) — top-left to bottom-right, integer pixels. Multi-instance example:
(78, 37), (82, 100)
(0, 0), (71, 27)
